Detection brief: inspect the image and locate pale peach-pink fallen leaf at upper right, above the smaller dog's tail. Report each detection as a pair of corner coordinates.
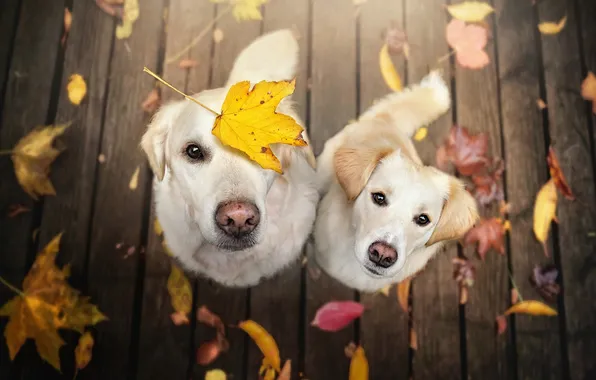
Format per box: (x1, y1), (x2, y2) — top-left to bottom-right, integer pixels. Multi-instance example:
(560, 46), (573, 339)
(446, 19), (490, 69)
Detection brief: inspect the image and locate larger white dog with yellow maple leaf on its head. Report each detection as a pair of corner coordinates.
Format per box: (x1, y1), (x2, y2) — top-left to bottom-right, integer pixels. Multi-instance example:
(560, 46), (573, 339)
(141, 30), (318, 287)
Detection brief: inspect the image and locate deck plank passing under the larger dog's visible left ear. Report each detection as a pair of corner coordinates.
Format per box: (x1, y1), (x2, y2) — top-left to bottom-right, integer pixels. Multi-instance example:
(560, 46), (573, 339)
(137, 0), (215, 379)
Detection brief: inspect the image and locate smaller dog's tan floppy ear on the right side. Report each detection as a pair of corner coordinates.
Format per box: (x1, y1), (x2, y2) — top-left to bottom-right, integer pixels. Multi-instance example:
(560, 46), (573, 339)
(426, 176), (478, 246)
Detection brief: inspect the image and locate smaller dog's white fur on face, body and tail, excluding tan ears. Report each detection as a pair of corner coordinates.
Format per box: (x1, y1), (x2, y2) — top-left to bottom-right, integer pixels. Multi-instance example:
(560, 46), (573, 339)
(314, 73), (475, 291)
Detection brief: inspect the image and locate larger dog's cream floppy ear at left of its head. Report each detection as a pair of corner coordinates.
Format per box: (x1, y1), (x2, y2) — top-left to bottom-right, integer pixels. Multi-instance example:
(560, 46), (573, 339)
(141, 101), (184, 181)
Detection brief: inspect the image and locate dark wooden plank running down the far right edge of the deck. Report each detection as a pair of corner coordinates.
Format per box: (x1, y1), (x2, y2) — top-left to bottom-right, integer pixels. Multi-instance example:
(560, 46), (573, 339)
(538, 2), (596, 379)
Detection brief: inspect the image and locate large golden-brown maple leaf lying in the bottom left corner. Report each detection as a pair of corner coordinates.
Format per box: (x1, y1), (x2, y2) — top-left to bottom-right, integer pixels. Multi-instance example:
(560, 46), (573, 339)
(0, 234), (106, 370)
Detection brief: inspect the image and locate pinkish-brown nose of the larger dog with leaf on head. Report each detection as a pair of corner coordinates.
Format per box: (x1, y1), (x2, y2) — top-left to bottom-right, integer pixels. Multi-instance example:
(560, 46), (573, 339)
(215, 201), (261, 239)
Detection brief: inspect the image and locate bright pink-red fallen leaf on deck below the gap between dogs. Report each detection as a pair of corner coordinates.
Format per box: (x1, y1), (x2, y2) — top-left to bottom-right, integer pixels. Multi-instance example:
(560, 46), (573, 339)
(310, 301), (364, 331)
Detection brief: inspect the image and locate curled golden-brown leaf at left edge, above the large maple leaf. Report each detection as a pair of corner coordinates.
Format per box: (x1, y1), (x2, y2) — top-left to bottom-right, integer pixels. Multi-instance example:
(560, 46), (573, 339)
(12, 124), (70, 200)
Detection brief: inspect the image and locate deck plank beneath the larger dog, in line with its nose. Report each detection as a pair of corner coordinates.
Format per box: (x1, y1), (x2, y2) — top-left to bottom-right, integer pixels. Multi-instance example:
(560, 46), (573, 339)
(193, 5), (261, 379)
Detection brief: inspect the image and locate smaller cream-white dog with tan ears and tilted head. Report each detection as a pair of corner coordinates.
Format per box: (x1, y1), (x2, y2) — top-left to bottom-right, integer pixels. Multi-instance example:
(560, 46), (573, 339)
(314, 73), (478, 291)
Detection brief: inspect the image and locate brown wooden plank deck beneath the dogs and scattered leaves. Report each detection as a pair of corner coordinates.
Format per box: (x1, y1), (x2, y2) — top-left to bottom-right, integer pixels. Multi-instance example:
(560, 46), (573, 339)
(0, 0), (596, 380)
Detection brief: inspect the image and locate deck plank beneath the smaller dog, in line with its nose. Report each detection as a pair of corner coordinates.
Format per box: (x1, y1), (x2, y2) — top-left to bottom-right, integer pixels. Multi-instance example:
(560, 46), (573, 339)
(359, 0), (410, 379)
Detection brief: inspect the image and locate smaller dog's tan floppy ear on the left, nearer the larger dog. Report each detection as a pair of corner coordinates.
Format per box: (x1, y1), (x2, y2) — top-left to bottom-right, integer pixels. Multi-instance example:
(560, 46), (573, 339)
(333, 145), (395, 202)
